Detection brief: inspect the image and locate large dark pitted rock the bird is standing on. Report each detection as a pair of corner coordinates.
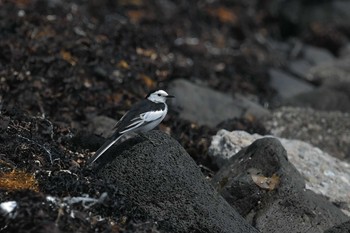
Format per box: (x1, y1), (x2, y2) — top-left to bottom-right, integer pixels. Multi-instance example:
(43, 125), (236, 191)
(94, 131), (257, 233)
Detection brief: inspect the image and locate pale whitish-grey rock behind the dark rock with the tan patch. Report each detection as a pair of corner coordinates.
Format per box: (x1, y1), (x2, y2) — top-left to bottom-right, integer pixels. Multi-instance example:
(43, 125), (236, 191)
(209, 130), (350, 215)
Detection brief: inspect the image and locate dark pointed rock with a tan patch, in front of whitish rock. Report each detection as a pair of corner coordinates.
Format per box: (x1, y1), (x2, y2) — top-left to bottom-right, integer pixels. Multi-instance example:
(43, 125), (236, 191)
(212, 138), (348, 233)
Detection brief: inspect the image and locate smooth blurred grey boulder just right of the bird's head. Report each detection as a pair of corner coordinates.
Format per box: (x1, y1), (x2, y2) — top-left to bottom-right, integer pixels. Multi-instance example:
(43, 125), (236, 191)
(168, 79), (269, 127)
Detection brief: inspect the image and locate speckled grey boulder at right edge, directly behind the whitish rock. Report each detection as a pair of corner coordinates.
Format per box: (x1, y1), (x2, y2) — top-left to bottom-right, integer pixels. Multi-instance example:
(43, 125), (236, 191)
(262, 107), (350, 159)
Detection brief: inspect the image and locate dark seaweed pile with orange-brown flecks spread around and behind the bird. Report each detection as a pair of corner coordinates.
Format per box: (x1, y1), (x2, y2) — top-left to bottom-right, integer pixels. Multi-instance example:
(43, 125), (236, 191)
(0, 0), (334, 232)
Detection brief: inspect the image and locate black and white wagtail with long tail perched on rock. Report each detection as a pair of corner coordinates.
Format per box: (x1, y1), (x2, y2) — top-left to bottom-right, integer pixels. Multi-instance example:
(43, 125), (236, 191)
(88, 90), (174, 165)
